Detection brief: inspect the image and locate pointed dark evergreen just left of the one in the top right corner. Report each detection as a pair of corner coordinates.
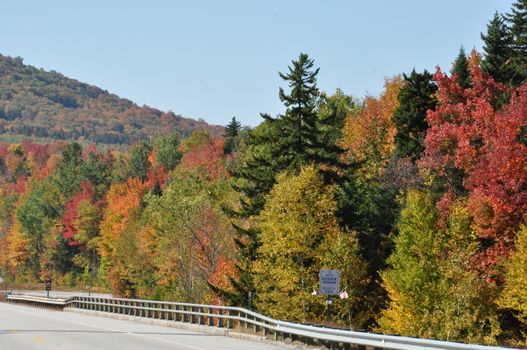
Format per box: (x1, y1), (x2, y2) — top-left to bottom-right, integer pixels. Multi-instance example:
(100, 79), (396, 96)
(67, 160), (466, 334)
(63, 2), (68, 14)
(481, 12), (512, 83)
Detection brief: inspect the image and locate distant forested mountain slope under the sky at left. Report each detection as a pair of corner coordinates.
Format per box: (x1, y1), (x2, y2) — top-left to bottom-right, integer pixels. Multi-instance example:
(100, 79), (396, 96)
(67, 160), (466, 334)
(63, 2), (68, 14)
(0, 55), (222, 144)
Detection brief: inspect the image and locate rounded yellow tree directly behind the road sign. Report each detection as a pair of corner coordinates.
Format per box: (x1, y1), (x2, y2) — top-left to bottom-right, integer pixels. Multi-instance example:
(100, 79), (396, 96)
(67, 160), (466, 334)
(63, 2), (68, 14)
(254, 167), (367, 321)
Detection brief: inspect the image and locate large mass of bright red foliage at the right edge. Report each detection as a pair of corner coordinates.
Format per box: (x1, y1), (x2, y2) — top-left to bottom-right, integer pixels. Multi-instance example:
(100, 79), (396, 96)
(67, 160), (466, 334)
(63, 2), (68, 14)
(421, 62), (527, 273)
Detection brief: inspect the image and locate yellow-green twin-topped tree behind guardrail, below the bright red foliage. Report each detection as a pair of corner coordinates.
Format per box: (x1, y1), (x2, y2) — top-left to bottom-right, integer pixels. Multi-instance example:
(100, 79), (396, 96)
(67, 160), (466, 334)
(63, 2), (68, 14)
(378, 194), (499, 344)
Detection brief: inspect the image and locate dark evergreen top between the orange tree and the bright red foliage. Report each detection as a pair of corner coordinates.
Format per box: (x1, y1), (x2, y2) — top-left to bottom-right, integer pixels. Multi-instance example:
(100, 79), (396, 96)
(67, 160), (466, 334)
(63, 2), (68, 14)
(392, 69), (437, 161)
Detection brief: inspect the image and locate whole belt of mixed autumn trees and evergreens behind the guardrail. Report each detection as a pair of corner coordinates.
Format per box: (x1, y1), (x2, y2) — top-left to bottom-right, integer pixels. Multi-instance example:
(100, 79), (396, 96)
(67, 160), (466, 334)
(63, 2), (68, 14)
(0, 0), (527, 347)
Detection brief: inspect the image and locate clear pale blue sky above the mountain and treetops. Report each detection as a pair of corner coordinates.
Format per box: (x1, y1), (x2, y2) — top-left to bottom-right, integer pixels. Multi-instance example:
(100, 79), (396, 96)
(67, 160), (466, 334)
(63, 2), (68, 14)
(0, 0), (513, 126)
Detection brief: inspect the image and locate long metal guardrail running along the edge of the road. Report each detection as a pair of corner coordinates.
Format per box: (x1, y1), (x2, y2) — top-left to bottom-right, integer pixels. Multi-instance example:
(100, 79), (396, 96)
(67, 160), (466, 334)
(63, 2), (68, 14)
(7, 295), (516, 350)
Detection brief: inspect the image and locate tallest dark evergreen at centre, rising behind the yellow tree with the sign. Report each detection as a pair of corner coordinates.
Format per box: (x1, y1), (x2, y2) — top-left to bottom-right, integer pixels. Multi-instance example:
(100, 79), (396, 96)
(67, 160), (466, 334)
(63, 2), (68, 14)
(216, 53), (344, 306)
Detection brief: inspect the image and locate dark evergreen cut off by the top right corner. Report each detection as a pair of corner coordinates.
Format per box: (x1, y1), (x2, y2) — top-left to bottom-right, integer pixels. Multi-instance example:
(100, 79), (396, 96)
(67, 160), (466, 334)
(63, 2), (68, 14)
(505, 0), (527, 85)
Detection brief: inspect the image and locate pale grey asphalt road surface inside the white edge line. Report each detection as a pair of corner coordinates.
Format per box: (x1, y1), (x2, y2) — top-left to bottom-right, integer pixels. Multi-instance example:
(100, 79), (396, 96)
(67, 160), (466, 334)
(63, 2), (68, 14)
(0, 303), (286, 350)
